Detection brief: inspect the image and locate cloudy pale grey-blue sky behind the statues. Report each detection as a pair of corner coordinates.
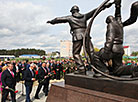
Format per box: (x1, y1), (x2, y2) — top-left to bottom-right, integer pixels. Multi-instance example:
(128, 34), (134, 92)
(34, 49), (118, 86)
(0, 0), (138, 52)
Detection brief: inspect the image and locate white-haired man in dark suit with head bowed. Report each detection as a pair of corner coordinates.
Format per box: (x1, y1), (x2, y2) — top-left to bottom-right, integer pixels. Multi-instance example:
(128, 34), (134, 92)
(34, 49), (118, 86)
(24, 63), (35, 102)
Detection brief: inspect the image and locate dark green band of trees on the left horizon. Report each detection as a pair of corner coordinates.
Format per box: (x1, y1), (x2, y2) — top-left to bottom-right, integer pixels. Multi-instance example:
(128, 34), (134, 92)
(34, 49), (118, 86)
(0, 48), (45, 57)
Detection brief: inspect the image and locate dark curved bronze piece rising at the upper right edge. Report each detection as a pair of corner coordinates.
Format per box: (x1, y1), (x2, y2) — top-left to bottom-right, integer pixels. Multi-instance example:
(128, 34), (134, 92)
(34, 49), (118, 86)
(123, 1), (138, 26)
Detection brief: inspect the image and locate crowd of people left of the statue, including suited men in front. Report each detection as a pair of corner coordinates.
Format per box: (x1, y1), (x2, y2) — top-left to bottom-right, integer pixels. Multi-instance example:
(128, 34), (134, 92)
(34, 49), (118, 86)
(0, 59), (90, 102)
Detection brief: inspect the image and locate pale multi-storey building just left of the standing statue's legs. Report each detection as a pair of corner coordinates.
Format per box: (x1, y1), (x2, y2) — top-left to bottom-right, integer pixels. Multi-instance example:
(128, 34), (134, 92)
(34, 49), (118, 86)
(60, 40), (72, 57)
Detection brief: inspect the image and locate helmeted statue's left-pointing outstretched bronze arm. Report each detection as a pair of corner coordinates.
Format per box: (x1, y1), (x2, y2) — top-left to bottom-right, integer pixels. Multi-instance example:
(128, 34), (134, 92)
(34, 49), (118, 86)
(47, 16), (69, 24)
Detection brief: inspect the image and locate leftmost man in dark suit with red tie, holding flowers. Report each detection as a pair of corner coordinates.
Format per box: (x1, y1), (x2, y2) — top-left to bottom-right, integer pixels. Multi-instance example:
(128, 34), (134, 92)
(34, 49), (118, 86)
(1, 63), (16, 102)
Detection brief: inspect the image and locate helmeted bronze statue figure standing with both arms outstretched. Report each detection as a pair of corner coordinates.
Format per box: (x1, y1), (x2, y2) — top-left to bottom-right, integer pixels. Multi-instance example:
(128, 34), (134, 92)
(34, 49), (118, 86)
(47, 2), (109, 74)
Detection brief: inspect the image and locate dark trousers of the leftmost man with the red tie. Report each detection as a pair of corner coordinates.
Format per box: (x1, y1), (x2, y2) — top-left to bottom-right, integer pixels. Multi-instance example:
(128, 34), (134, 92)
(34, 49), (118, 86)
(1, 88), (16, 102)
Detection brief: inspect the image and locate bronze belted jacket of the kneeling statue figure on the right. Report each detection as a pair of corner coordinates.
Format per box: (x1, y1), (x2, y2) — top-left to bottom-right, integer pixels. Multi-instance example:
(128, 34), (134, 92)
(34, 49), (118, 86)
(104, 21), (124, 53)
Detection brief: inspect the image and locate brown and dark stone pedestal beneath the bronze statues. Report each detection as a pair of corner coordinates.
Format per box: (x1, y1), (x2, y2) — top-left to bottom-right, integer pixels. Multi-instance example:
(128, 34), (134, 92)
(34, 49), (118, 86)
(46, 74), (138, 102)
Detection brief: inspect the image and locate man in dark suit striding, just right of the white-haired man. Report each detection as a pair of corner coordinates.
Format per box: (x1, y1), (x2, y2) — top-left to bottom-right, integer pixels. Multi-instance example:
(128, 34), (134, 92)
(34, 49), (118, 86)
(35, 63), (48, 99)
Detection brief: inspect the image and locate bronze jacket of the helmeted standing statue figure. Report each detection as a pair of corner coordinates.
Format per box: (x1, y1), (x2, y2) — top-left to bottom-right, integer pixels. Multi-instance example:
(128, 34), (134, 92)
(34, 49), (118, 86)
(49, 9), (96, 41)
